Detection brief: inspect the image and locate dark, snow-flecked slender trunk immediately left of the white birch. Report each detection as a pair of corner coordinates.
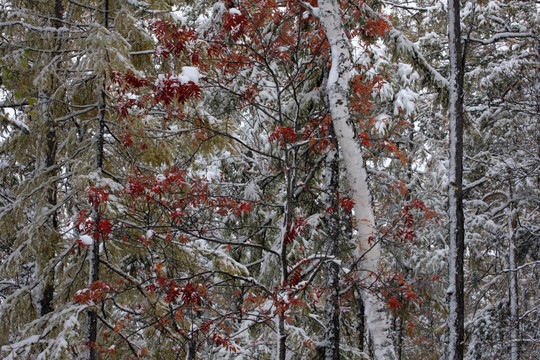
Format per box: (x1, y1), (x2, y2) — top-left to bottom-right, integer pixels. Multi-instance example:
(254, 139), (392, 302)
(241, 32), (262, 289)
(324, 137), (340, 360)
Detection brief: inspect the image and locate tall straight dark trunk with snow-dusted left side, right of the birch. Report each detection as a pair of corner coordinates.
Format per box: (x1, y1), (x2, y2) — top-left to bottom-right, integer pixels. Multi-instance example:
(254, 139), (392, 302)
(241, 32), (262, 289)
(447, 0), (465, 360)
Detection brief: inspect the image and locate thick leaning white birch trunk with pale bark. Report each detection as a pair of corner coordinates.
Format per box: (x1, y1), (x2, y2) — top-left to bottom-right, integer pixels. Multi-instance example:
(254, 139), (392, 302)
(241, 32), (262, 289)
(319, 0), (395, 360)
